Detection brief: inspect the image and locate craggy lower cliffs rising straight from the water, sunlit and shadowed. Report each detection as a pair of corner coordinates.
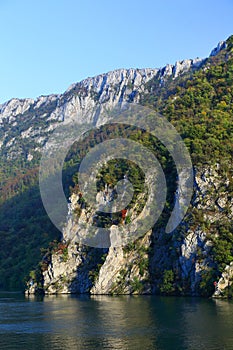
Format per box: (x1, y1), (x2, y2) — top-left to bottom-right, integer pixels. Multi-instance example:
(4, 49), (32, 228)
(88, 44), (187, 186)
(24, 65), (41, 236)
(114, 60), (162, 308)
(27, 164), (233, 296)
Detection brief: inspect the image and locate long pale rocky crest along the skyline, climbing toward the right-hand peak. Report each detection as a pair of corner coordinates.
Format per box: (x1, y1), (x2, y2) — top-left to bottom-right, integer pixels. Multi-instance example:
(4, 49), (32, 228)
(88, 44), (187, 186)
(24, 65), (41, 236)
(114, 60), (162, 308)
(0, 41), (226, 164)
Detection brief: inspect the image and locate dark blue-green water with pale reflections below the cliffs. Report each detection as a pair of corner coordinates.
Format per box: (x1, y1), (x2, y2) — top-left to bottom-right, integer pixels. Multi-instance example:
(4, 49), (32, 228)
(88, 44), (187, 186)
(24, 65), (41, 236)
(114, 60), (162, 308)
(0, 293), (233, 350)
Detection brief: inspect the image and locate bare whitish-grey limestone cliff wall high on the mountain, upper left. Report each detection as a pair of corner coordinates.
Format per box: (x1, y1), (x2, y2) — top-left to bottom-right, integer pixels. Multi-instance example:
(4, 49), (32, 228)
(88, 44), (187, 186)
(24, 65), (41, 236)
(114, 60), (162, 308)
(0, 59), (204, 162)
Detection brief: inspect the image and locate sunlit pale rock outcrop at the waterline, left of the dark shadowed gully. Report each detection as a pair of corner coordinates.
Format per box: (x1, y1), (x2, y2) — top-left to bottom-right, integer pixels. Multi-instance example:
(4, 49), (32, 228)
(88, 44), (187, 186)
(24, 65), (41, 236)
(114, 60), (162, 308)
(27, 189), (151, 294)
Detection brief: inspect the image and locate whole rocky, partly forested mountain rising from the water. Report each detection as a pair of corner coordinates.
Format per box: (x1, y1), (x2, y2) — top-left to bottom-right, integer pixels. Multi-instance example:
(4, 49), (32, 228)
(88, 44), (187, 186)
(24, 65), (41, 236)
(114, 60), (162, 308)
(0, 37), (233, 295)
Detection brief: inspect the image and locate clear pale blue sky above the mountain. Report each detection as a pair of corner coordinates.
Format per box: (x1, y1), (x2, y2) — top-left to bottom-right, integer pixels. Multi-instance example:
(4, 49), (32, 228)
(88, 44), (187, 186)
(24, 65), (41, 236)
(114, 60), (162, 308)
(0, 0), (233, 103)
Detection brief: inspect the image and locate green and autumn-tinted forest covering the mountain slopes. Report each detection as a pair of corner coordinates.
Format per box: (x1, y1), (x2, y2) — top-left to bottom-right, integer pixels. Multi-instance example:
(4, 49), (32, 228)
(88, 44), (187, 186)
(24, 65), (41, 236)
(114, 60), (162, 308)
(0, 37), (233, 295)
